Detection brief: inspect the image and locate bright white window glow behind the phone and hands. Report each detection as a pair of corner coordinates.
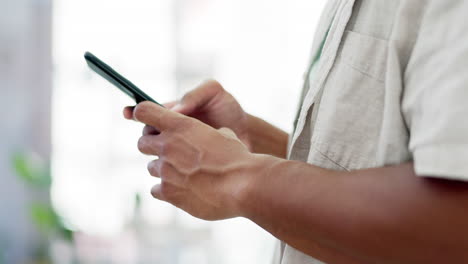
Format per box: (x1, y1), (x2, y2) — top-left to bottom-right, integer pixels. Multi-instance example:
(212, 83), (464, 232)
(52, 0), (325, 264)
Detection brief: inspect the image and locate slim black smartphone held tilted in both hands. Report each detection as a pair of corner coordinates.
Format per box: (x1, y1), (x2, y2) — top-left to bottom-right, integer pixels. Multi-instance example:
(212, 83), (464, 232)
(84, 52), (164, 107)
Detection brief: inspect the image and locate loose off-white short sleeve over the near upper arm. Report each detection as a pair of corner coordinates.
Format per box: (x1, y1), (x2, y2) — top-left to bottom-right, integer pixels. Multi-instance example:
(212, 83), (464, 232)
(402, 0), (468, 181)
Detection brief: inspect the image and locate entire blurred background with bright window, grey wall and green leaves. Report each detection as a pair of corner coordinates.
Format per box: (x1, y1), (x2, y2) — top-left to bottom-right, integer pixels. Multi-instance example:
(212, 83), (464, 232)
(0, 0), (326, 264)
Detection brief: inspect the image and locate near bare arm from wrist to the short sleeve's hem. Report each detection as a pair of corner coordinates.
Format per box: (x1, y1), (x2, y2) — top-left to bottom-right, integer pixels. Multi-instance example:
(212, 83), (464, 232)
(243, 157), (468, 264)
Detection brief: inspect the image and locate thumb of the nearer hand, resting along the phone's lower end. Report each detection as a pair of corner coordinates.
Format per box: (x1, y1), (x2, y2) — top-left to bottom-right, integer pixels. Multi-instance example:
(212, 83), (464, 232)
(133, 101), (192, 132)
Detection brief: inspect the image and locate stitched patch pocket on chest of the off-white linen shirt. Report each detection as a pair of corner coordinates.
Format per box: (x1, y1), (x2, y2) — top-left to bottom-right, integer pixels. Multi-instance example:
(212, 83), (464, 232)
(308, 31), (388, 170)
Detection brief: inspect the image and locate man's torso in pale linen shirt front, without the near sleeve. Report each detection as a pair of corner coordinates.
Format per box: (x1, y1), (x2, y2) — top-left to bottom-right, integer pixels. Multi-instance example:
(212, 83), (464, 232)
(276, 0), (424, 264)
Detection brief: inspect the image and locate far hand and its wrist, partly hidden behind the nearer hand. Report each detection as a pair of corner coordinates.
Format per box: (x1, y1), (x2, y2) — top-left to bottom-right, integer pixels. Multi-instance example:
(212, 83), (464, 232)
(124, 80), (288, 158)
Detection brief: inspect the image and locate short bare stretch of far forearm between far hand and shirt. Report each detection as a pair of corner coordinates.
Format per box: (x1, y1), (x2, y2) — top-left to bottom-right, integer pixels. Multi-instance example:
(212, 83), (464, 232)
(248, 115), (288, 158)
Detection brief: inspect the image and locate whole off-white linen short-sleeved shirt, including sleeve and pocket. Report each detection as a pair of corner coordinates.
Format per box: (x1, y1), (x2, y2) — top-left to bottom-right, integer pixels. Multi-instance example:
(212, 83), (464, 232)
(274, 0), (468, 264)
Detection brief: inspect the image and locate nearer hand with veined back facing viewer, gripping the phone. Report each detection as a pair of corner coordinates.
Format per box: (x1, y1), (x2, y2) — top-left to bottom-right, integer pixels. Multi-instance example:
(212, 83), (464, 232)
(127, 102), (253, 220)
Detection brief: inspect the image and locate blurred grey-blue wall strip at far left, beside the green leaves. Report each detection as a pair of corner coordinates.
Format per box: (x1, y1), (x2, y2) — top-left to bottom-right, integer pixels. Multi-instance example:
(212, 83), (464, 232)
(0, 0), (52, 263)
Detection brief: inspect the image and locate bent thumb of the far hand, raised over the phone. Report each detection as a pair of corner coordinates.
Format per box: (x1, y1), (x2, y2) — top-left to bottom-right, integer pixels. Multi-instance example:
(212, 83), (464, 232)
(172, 80), (224, 115)
